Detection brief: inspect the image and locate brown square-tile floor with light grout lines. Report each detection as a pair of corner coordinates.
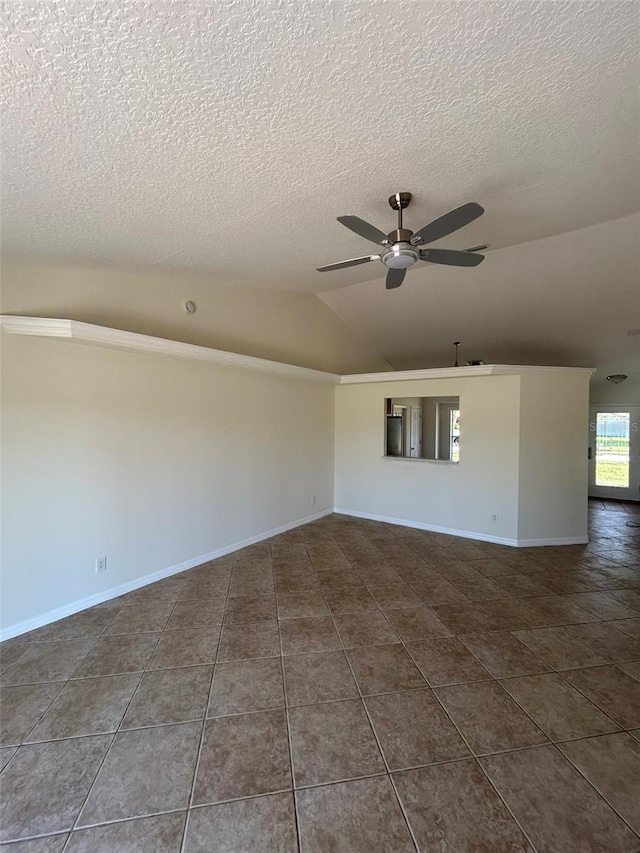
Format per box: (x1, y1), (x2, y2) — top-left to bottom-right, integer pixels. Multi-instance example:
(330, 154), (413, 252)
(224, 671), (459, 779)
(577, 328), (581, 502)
(0, 501), (640, 853)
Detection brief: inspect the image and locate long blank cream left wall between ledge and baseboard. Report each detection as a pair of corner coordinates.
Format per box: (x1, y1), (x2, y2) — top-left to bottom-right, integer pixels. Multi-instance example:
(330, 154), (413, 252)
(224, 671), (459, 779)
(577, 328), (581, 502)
(1, 334), (334, 632)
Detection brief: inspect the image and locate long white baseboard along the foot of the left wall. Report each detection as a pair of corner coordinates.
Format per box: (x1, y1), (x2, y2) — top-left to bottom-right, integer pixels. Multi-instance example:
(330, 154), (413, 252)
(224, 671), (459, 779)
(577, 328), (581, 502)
(0, 507), (334, 642)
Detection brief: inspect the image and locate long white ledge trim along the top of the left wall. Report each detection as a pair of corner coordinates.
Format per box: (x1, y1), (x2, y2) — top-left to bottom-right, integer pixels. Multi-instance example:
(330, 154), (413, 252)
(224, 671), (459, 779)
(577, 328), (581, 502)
(0, 314), (340, 385)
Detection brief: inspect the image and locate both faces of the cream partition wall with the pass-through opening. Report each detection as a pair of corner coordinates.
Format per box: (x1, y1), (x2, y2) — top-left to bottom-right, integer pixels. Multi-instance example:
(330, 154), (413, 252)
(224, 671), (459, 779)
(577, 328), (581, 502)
(335, 368), (589, 545)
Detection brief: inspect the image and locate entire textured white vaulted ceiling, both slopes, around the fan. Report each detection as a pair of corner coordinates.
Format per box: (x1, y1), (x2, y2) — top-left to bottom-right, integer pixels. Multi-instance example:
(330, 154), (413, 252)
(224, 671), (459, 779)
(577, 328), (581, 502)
(2, 0), (640, 367)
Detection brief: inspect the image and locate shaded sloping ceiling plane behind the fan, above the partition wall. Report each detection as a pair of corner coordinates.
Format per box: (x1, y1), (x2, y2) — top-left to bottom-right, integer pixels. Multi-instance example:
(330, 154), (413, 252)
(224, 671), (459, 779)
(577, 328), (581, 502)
(322, 214), (640, 372)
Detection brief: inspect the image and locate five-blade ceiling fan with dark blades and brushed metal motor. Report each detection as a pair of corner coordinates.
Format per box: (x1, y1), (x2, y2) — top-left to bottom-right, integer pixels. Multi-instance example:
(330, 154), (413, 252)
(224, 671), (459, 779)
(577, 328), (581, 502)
(318, 193), (487, 290)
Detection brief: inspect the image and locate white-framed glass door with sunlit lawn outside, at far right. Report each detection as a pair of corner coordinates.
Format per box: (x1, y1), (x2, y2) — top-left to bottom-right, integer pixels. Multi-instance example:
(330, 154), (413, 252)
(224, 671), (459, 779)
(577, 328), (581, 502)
(589, 406), (640, 501)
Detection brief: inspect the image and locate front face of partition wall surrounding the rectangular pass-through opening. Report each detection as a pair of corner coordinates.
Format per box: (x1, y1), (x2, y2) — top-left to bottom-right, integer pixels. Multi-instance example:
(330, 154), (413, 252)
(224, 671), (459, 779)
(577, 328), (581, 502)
(335, 376), (520, 542)
